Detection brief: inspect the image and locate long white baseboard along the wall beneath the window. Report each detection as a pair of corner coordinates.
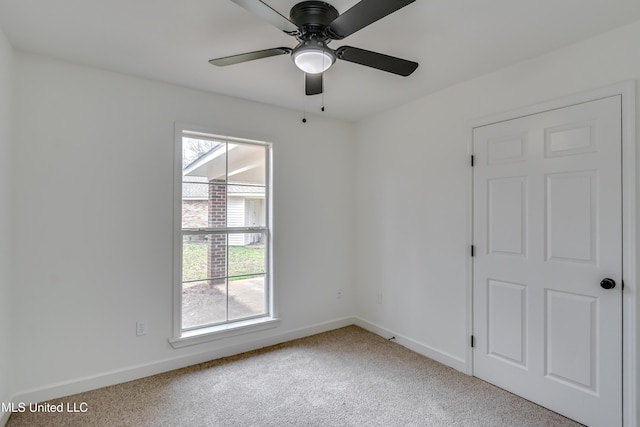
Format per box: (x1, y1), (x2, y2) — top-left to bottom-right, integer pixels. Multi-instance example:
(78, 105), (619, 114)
(8, 317), (354, 408)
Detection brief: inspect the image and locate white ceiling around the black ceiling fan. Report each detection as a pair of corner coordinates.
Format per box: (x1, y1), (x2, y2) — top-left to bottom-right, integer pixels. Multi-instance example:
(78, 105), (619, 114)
(0, 0), (640, 120)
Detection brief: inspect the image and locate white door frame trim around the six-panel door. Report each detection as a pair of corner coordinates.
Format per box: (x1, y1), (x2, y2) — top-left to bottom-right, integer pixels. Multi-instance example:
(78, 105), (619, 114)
(465, 80), (640, 427)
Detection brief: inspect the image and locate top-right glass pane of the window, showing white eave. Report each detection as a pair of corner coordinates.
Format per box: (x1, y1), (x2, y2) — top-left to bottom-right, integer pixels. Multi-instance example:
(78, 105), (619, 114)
(227, 142), (267, 186)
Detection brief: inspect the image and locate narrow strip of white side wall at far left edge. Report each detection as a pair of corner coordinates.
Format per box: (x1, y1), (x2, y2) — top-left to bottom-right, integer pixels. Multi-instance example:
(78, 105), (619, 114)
(0, 22), (13, 423)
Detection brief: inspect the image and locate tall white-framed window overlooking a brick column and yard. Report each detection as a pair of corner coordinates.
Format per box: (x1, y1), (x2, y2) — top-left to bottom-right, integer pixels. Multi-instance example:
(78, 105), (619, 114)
(171, 129), (275, 347)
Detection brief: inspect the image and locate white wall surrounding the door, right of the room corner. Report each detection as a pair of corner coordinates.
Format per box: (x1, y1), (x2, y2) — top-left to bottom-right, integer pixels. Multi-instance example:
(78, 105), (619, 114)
(356, 16), (640, 422)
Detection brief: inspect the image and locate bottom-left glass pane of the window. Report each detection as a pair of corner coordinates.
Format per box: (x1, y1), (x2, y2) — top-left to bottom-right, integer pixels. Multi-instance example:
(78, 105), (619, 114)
(182, 280), (227, 329)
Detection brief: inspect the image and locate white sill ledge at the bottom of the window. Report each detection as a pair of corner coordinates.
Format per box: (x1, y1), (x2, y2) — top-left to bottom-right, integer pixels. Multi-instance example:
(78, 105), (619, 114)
(169, 317), (280, 348)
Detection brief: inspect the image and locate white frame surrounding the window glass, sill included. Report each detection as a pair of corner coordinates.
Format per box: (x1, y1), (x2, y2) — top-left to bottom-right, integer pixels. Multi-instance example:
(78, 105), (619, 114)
(169, 123), (280, 348)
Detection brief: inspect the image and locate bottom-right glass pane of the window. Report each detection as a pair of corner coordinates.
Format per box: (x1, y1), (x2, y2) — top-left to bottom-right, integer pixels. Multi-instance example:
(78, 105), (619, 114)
(229, 275), (267, 320)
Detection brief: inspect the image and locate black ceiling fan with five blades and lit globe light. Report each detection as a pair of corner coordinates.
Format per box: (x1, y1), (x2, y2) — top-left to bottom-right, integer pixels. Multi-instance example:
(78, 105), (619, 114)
(209, 0), (418, 95)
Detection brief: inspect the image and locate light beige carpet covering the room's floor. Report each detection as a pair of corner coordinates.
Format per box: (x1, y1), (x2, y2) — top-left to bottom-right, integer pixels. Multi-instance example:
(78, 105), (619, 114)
(7, 326), (579, 427)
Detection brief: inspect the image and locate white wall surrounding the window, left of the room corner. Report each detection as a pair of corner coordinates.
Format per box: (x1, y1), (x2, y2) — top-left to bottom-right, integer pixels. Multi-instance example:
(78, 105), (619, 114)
(12, 53), (354, 399)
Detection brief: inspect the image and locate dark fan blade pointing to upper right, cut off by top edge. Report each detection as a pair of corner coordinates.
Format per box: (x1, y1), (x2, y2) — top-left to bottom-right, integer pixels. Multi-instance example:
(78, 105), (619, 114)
(329, 0), (415, 40)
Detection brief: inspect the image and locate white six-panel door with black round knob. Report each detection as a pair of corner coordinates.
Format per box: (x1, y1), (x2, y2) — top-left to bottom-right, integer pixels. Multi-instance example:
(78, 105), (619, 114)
(473, 96), (622, 427)
